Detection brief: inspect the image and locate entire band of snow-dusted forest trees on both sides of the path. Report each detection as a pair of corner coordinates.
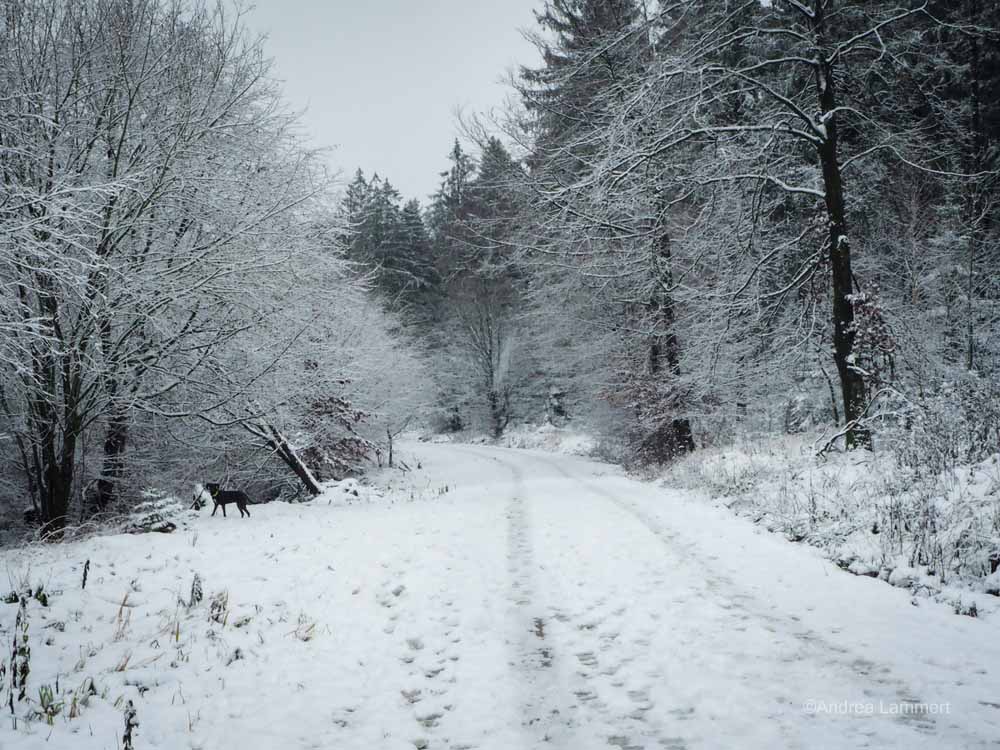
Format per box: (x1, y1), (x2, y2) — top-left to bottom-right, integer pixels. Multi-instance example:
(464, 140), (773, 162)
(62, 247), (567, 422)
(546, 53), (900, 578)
(0, 0), (1000, 526)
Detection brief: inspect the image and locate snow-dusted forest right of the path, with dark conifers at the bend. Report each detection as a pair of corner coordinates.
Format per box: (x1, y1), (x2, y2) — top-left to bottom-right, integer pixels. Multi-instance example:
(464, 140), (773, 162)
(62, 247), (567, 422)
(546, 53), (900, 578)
(344, 0), (1000, 460)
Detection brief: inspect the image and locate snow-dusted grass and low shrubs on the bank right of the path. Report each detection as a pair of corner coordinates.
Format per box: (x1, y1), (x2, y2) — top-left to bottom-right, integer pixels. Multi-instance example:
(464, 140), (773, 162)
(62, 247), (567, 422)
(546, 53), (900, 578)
(665, 436), (1000, 609)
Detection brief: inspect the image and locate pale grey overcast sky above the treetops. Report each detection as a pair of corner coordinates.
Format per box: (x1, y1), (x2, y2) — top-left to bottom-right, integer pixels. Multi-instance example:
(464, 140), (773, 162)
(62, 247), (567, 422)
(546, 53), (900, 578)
(247, 0), (541, 203)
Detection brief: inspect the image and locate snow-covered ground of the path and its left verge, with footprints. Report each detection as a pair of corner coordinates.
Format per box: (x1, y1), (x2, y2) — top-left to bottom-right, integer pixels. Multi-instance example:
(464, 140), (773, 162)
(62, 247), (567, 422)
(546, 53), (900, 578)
(0, 444), (1000, 750)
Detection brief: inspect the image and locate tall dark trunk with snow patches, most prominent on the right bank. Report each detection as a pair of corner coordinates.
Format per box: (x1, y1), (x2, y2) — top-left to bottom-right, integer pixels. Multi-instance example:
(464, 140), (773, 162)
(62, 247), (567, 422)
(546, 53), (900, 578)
(813, 0), (872, 449)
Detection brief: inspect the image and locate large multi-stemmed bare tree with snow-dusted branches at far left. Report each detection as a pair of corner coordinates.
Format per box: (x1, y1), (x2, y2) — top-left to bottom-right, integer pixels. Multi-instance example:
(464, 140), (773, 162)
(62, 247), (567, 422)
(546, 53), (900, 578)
(0, 0), (332, 528)
